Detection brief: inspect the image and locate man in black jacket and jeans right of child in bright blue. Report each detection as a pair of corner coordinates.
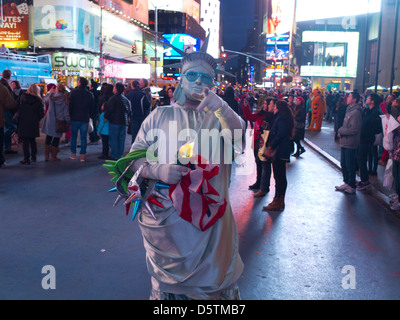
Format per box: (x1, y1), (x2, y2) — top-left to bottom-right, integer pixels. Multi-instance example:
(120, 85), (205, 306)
(104, 82), (130, 160)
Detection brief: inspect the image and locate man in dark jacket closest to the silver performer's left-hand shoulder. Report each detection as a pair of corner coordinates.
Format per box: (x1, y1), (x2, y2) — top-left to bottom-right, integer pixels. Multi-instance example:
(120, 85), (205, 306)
(126, 80), (150, 144)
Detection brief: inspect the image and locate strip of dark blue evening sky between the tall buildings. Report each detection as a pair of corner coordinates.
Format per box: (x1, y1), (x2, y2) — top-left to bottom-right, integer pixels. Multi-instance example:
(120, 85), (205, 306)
(220, 0), (255, 65)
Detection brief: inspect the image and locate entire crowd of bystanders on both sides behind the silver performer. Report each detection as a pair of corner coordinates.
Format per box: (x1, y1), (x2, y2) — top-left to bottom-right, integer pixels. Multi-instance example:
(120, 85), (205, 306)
(0, 66), (400, 210)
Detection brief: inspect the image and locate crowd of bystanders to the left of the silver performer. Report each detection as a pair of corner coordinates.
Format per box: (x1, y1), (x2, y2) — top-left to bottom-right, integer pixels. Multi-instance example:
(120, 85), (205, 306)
(0, 70), (152, 167)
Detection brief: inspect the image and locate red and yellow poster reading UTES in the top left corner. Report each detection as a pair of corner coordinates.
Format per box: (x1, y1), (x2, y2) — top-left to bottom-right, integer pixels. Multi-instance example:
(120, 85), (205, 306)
(0, 0), (33, 48)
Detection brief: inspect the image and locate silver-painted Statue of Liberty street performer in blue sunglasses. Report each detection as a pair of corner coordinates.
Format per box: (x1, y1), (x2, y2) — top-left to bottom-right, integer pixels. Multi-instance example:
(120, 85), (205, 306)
(104, 37), (245, 300)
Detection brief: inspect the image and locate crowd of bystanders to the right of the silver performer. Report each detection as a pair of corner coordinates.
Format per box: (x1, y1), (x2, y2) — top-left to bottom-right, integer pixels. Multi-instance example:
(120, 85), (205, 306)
(219, 88), (400, 210)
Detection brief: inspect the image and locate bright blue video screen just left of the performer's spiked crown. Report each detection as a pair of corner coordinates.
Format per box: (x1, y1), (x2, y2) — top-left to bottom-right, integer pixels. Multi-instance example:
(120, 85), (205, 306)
(164, 33), (201, 60)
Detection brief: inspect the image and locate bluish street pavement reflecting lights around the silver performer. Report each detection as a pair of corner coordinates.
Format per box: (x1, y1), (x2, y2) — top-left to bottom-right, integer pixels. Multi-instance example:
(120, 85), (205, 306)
(0, 123), (400, 300)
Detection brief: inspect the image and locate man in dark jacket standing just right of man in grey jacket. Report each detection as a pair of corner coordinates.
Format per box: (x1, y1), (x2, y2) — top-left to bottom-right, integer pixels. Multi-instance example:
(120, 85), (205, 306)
(357, 93), (382, 191)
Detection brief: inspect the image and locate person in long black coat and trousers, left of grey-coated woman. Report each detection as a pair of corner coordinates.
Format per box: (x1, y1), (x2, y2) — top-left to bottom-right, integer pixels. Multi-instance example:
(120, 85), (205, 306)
(15, 84), (44, 165)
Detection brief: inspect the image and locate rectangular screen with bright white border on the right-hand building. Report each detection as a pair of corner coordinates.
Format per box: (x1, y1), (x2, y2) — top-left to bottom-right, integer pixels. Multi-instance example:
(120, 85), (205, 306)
(300, 31), (360, 78)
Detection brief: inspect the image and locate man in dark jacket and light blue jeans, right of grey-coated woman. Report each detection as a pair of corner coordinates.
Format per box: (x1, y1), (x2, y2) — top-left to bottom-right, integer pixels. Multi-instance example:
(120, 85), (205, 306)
(69, 78), (94, 162)
